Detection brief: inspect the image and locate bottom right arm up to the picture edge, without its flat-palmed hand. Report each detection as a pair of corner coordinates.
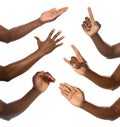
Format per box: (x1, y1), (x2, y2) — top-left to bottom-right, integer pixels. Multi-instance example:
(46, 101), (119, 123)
(80, 98), (120, 120)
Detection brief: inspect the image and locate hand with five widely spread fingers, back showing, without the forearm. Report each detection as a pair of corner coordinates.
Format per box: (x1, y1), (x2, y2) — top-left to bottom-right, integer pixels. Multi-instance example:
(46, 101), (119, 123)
(35, 29), (64, 55)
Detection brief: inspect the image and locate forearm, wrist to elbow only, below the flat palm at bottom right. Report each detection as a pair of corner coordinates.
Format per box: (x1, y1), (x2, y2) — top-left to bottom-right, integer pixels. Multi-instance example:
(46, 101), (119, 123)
(81, 101), (118, 120)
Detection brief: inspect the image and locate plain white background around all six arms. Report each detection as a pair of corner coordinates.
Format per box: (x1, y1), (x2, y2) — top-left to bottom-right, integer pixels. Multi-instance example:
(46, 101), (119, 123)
(0, 0), (120, 127)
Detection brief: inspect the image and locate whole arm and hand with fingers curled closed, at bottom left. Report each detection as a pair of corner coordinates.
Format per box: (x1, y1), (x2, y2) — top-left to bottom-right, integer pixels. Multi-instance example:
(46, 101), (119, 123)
(0, 71), (56, 120)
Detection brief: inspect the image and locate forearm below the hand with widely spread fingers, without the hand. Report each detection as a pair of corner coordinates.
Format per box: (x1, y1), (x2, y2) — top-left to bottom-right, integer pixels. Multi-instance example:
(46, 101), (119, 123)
(0, 50), (45, 81)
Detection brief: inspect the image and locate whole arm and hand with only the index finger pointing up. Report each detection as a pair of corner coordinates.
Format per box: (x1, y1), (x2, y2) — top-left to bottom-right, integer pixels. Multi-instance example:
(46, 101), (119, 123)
(82, 7), (120, 59)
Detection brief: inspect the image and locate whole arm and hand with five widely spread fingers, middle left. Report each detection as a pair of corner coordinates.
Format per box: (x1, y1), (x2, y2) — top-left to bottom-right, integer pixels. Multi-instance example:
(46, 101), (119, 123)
(0, 29), (64, 81)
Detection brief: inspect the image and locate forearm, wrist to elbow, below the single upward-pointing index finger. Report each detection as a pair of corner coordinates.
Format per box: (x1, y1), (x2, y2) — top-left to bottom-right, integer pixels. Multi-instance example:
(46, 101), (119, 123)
(91, 33), (115, 58)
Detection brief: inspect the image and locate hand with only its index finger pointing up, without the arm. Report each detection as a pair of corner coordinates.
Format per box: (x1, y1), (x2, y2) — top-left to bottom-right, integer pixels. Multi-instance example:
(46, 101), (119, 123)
(82, 7), (101, 36)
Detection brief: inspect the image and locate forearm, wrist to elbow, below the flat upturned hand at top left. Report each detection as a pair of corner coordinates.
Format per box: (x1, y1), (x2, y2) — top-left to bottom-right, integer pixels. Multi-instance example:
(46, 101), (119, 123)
(3, 19), (44, 43)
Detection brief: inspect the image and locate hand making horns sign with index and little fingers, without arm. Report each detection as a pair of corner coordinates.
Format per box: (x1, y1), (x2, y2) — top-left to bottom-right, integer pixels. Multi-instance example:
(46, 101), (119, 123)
(64, 45), (89, 75)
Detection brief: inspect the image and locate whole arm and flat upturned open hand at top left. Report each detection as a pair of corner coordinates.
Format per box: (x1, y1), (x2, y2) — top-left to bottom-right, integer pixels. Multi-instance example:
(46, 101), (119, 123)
(0, 7), (68, 43)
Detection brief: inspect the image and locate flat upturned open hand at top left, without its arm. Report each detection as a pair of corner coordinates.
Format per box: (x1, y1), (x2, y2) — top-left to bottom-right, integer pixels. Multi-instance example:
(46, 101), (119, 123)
(40, 7), (68, 23)
